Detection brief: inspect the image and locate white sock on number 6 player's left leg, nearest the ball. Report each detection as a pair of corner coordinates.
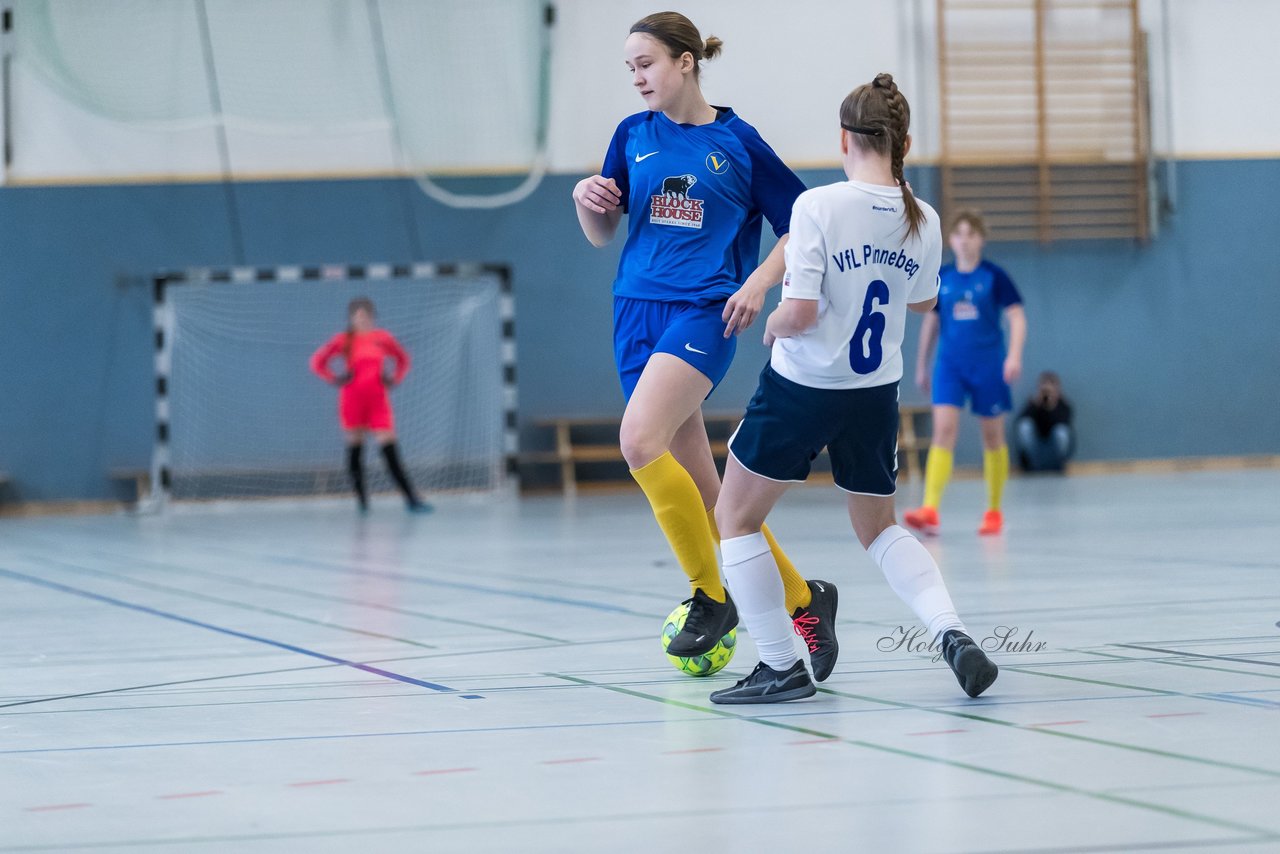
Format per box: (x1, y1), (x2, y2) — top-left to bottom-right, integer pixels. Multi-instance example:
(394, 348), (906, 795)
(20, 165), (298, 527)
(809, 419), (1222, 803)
(721, 533), (800, 670)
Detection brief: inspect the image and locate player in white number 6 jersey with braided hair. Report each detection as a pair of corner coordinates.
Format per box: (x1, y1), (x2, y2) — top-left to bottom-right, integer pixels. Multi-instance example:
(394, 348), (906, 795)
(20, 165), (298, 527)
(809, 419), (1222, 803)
(710, 74), (997, 703)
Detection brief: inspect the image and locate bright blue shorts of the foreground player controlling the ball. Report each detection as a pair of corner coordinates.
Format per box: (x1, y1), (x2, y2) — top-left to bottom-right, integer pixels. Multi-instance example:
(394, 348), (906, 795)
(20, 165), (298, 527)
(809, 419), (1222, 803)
(613, 297), (737, 401)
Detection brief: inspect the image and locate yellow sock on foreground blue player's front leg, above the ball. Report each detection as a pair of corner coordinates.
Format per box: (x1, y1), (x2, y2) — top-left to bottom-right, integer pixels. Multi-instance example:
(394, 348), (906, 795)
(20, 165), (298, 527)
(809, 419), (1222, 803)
(631, 451), (724, 602)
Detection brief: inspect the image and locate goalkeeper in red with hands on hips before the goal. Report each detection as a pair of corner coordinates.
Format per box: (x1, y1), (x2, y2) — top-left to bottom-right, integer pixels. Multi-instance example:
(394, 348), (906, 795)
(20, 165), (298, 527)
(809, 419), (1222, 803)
(311, 297), (431, 513)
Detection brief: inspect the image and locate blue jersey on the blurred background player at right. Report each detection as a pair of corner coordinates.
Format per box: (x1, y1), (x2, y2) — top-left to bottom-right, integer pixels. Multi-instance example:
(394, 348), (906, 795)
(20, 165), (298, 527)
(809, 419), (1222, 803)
(934, 261), (1023, 364)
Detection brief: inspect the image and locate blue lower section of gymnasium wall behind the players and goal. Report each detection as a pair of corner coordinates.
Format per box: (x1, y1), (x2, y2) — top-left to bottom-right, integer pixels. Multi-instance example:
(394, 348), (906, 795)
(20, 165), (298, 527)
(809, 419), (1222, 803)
(0, 160), (1280, 501)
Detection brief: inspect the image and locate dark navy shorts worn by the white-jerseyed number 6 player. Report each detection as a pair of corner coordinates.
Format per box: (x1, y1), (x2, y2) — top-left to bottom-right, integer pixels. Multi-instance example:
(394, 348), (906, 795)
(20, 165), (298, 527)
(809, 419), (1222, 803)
(728, 364), (897, 495)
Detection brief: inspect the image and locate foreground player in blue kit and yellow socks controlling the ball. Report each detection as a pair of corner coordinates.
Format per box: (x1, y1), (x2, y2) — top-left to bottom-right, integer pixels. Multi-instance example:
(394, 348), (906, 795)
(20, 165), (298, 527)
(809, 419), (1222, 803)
(573, 12), (837, 679)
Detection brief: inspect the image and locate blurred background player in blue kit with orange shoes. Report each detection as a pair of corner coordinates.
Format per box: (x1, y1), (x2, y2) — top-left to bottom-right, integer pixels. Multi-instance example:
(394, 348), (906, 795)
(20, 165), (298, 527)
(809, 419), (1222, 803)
(904, 210), (1027, 534)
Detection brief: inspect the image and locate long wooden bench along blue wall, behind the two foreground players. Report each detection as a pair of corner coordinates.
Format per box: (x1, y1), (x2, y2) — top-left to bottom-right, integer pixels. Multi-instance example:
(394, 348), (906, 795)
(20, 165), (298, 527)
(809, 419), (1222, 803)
(520, 406), (932, 495)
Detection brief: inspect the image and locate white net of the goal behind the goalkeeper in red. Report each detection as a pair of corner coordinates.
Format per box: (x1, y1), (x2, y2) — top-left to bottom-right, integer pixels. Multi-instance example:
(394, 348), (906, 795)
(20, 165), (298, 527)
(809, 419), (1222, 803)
(163, 274), (507, 499)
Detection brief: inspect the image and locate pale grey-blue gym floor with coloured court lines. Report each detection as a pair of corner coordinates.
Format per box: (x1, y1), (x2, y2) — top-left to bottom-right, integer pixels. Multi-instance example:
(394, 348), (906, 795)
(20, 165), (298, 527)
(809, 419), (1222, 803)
(0, 470), (1280, 853)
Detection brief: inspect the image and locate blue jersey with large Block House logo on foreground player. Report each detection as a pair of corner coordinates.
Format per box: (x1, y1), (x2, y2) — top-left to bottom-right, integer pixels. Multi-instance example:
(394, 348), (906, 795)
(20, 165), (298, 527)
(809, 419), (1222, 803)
(600, 106), (805, 303)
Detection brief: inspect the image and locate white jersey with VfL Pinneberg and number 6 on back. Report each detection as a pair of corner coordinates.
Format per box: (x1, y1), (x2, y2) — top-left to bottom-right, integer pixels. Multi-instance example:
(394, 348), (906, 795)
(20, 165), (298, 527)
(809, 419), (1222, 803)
(771, 181), (942, 388)
